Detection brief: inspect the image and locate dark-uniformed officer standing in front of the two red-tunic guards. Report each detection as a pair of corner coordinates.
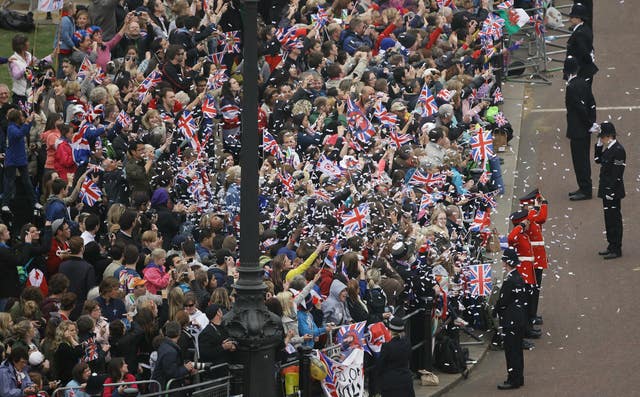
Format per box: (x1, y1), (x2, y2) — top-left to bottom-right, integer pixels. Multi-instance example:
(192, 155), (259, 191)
(494, 248), (527, 390)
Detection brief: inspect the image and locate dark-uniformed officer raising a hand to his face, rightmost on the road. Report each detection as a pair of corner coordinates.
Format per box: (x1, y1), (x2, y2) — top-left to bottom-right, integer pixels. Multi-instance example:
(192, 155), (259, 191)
(595, 122), (627, 259)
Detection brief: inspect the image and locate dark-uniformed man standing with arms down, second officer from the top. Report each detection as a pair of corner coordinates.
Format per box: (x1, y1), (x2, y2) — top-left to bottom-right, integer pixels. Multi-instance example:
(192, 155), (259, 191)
(564, 56), (596, 201)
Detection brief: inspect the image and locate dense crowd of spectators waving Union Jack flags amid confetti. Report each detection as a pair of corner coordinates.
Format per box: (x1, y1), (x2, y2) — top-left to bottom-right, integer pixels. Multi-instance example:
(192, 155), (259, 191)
(0, 0), (560, 397)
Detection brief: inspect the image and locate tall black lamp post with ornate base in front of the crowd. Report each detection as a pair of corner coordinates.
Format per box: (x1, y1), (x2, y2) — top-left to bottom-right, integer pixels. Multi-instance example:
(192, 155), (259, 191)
(224, 0), (284, 397)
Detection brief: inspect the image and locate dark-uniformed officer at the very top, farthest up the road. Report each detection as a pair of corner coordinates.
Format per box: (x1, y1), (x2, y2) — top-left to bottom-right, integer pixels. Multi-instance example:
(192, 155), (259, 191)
(563, 4), (598, 87)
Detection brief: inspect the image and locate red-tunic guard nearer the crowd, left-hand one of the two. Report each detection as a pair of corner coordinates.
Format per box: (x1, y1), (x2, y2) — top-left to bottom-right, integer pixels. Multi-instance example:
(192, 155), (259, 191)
(508, 210), (541, 339)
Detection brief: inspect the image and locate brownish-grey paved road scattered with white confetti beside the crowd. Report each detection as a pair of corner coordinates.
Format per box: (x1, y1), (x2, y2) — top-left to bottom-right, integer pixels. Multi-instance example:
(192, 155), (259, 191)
(447, 0), (640, 396)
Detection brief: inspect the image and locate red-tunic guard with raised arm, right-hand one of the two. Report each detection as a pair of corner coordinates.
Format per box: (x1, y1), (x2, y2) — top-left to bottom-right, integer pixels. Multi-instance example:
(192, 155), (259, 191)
(520, 189), (549, 325)
